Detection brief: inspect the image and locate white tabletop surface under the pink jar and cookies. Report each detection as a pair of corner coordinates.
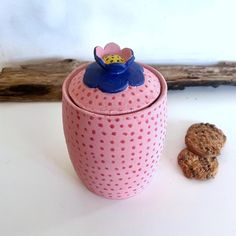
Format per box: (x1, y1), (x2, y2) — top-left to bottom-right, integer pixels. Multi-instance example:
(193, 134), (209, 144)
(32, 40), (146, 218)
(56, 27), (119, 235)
(0, 86), (236, 236)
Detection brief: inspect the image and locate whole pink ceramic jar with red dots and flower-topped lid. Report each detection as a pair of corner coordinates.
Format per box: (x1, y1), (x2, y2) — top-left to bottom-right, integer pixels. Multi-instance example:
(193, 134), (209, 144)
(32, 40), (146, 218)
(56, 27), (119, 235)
(62, 43), (167, 199)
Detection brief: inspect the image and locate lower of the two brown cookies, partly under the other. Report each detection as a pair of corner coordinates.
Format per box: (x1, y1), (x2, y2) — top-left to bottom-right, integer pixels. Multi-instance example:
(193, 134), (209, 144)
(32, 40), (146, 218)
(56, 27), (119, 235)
(178, 148), (218, 180)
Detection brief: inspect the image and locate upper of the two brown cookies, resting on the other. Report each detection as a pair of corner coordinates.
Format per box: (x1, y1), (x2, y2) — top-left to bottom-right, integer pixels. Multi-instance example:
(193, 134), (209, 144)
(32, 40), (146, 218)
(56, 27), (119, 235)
(185, 123), (226, 157)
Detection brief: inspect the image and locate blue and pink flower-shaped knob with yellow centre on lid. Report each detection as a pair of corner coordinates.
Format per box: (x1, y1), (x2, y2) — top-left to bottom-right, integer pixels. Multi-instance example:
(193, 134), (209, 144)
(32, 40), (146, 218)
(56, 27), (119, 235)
(83, 43), (144, 93)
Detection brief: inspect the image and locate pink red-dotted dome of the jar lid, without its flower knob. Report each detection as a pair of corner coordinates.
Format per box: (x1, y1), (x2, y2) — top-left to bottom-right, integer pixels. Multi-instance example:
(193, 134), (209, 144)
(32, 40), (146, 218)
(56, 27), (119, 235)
(69, 66), (160, 115)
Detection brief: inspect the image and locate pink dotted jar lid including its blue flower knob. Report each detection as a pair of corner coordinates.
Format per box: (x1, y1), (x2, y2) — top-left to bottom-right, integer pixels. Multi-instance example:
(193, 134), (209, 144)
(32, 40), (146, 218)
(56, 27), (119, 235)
(68, 43), (161, 115)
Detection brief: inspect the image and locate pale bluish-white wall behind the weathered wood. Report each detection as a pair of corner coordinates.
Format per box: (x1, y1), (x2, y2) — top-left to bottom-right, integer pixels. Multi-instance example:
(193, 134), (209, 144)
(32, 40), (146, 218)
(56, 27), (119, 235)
(0, 0), (236, 67)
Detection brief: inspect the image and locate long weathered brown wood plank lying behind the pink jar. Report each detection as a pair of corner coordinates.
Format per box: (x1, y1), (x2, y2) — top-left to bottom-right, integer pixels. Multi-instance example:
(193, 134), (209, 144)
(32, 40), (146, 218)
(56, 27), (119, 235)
(0, 59), (236, 102)
